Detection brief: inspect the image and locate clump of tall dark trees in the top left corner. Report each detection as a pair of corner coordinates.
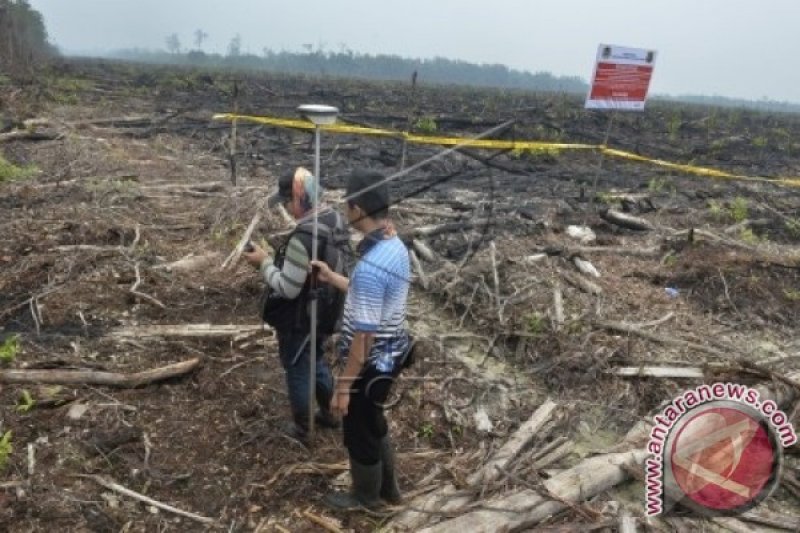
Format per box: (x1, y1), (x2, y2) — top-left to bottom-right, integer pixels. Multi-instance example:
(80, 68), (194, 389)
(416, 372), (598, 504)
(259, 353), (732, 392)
(0, 0), (55, 73)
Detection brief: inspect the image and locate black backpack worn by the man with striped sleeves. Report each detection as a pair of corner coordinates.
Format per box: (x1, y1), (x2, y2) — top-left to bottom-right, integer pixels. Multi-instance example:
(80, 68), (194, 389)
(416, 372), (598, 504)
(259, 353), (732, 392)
(261, 211), (353, 335)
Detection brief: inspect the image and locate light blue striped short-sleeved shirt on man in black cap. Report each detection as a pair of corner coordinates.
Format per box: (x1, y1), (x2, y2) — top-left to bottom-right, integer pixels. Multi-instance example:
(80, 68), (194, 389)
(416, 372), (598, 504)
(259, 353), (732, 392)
(338, 236), (410, 373)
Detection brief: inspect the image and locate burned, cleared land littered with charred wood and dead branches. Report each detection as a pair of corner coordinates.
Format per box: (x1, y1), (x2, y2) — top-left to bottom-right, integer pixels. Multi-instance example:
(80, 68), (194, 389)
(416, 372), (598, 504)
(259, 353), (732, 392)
(0, 61), (800, 532)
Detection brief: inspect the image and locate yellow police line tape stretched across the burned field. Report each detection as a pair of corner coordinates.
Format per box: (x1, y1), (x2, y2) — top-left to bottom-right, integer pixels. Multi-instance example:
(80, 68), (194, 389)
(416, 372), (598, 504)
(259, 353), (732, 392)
(212, 113), (800, 187)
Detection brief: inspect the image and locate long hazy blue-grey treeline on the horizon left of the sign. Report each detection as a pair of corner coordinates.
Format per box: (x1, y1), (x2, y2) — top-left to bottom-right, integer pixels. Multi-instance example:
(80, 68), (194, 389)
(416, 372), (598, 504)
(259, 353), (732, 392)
(113, 49), (588, 93)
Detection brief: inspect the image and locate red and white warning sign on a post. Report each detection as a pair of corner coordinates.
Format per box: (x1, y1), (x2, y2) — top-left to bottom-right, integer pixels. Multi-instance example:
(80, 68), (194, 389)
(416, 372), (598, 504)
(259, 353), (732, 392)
(585, 44), (656, 111)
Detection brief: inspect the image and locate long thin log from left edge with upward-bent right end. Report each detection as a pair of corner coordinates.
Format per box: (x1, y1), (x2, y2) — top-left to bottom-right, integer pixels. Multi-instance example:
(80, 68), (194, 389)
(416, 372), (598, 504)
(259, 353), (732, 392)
(0, 358), (200, 389)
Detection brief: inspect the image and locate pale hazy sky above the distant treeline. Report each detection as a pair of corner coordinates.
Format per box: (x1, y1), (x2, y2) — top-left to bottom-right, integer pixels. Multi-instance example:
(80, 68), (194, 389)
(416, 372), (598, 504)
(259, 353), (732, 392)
(30, 0), (800, 102)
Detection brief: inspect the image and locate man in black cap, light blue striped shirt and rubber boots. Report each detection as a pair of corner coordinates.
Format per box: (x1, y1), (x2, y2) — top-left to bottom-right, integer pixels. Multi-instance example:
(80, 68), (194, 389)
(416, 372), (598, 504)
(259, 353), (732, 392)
(314, 171), (410, 509)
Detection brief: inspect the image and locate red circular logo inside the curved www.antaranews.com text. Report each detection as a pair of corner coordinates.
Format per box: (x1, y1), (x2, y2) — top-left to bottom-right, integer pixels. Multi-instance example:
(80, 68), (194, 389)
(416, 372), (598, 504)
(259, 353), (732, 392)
(666, 401), (781, 514)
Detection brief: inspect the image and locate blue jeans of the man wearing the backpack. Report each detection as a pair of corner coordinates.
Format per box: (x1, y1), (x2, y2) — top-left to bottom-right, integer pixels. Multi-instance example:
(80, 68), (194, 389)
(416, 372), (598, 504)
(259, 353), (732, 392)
(278, 331), (333, 428)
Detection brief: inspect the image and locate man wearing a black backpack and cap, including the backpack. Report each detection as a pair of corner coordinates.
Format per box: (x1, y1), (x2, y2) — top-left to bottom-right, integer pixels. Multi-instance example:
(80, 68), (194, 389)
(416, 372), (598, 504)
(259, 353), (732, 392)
(242, 167), (351, 445)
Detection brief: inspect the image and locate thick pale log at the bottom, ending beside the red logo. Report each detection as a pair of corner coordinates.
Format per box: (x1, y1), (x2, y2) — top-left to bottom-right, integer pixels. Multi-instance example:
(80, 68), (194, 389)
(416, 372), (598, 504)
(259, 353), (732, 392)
(419, 450), (648, 533)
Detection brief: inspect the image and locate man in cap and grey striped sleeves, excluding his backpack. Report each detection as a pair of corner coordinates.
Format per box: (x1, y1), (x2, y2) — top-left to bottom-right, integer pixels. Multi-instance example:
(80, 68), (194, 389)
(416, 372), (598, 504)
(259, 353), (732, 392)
(243, 167), (345, 444)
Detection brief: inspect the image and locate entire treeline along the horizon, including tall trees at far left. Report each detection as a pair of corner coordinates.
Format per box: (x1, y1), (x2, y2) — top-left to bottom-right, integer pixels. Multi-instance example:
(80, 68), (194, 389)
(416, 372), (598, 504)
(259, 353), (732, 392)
(0, 0), (800, 113)
